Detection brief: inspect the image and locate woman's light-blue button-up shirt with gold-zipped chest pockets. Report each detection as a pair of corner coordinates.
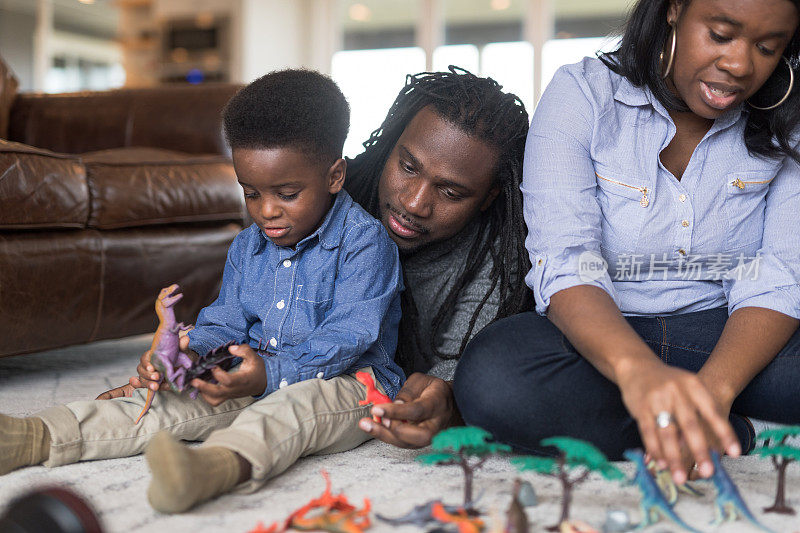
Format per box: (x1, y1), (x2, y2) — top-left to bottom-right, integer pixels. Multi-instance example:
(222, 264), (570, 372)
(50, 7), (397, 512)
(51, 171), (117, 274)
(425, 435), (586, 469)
(521, 58), (800, 318)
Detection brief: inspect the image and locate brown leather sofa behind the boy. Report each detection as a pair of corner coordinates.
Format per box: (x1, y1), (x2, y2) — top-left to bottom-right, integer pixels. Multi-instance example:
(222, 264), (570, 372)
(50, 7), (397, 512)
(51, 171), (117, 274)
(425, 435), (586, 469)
(0, 69), (244, 357)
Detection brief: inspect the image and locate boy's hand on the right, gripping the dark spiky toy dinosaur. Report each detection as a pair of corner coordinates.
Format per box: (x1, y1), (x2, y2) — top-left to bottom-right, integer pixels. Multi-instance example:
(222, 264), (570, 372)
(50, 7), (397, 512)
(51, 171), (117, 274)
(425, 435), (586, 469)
(191, 344), (267, 407)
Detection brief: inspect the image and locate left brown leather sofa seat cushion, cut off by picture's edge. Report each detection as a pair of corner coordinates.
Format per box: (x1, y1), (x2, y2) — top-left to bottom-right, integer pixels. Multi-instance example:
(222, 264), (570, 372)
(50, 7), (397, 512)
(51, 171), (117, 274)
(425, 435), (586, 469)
(0, 140), (89, 229)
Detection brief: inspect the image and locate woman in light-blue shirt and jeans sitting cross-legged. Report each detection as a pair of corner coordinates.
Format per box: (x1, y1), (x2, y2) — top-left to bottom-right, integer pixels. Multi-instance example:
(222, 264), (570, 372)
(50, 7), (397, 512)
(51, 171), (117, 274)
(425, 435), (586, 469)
(454, 0), (800, 483)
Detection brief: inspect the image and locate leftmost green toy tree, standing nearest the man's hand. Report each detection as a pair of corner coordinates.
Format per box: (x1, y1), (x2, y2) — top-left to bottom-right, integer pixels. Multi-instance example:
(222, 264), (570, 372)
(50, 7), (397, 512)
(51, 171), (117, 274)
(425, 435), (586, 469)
(417, 426), (511, 509)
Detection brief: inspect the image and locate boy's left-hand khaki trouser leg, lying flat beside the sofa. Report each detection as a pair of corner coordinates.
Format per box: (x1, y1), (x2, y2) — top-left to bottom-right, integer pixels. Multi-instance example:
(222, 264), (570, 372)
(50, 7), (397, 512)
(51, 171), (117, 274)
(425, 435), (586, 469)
(25, 389), (253, 466)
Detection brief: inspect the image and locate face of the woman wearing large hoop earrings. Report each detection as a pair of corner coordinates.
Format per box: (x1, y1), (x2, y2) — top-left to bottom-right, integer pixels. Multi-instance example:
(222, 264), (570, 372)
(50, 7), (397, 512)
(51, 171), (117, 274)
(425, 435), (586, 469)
(665, 0), (799, 119)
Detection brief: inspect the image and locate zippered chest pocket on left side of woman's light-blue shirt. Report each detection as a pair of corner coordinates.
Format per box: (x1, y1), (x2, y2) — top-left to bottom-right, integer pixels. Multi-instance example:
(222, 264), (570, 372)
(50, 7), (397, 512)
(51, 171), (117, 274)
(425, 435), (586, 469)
(595, 169), (652, 253)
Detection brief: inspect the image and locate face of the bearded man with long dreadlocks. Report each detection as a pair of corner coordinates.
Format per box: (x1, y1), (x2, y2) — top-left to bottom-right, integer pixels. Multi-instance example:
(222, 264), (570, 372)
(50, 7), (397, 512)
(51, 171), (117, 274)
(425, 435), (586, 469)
(378, 106), (500, 253)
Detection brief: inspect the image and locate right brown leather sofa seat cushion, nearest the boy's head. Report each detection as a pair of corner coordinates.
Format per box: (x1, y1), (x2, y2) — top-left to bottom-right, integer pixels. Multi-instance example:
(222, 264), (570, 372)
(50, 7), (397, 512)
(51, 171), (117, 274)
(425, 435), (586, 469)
(82, 148), (244, 229)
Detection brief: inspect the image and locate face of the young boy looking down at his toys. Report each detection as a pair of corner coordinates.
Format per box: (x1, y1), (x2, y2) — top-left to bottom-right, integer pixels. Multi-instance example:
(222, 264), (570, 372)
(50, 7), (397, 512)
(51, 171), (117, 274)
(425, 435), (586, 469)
(233, 147), (346, 248)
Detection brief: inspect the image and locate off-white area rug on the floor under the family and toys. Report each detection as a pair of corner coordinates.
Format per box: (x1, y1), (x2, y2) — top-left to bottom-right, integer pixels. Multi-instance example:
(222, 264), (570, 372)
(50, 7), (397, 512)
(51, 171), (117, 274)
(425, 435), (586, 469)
(0, 336), (800, 533)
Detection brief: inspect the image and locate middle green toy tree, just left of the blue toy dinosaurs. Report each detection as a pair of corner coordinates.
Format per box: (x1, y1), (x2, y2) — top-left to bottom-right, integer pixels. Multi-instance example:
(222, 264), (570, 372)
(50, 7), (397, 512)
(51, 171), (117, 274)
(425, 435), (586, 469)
(511, 437), (625, 531)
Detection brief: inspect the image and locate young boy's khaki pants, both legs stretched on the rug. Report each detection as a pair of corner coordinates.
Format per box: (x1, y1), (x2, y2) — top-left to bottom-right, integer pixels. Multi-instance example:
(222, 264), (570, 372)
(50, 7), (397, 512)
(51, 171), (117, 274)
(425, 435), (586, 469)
(33, 368), (380, 491)
